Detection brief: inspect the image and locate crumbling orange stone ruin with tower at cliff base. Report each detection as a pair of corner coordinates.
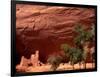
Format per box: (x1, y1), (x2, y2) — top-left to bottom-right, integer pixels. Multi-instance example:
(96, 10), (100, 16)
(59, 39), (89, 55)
(16, 50), (44, 72)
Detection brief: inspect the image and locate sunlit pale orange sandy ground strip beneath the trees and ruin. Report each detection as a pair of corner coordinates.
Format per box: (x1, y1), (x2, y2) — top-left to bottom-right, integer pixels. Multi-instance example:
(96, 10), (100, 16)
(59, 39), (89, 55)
(26, 63), (95, 72)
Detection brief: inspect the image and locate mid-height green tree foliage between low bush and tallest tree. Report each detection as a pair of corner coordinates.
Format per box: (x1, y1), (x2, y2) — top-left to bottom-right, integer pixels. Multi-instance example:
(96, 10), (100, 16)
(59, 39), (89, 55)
(61, 44), (83, 65)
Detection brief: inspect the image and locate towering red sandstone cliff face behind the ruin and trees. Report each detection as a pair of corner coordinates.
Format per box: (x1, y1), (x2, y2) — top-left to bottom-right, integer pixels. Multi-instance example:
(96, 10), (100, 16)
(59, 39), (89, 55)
(16, 4), (95, 62)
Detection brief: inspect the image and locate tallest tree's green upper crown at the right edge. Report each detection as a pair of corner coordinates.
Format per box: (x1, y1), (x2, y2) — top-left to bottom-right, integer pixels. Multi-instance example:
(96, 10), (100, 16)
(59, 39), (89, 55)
(74, 24), (95, 46)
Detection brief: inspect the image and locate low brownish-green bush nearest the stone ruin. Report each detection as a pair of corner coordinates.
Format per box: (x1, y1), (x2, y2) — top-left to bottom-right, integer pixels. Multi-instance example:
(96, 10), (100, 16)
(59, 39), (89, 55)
(47, 55), (62, 71)
